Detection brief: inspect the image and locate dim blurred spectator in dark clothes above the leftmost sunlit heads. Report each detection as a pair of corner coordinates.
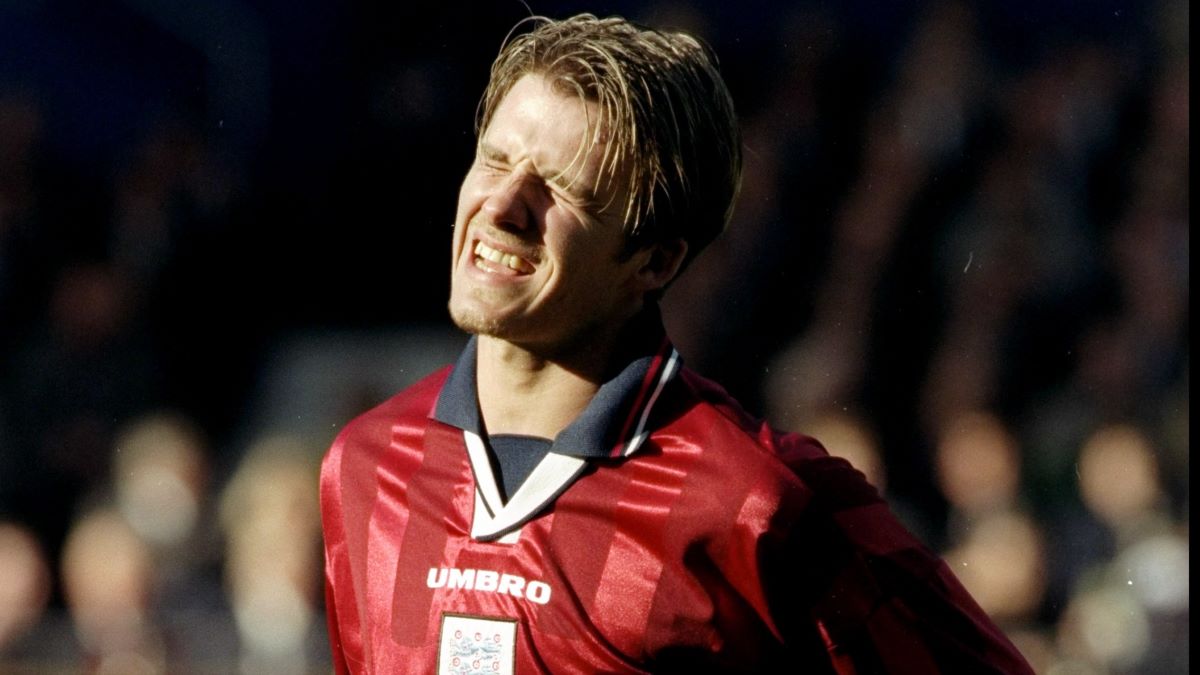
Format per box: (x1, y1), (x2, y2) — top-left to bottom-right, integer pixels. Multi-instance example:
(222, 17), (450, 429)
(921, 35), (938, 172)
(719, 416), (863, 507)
(5, 263), (158, 569)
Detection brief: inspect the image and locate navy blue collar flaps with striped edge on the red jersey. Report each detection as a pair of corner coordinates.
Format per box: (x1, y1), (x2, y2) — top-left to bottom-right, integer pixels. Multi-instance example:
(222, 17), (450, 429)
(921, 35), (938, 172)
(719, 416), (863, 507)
(432, 323), (682, 459)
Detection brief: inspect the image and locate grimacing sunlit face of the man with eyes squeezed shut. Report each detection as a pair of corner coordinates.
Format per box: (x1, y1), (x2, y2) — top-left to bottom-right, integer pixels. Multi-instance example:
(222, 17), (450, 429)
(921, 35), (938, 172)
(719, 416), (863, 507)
(450, 74), (659, 350)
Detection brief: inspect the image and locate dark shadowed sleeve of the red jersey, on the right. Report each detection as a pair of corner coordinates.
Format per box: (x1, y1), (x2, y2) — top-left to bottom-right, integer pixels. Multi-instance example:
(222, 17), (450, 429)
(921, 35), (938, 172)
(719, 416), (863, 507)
(763, 444), (1032, 675)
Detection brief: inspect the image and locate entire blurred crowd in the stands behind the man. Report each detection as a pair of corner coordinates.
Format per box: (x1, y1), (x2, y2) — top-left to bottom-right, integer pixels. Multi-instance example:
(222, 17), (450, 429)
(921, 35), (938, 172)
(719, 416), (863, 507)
(0, 0), (1190, 675)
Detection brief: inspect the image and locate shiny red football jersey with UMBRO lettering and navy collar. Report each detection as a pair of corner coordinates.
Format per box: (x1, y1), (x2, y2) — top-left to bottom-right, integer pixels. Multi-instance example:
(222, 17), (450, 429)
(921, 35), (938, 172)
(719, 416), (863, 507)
(320, 333), (1030, 674)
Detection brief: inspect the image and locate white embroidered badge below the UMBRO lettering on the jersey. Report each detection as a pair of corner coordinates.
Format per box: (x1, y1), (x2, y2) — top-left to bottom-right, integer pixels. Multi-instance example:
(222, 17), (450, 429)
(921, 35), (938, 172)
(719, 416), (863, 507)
(438, 614), (517, 675)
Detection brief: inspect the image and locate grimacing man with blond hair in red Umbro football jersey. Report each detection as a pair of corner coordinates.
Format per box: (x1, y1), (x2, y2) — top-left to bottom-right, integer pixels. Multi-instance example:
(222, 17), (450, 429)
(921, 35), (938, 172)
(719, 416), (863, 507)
(320, 16), (1028, 674)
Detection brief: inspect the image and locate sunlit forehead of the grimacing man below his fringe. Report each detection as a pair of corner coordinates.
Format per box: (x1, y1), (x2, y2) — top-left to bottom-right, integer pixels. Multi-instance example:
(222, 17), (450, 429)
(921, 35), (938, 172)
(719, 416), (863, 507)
(480, 74), (624, 198)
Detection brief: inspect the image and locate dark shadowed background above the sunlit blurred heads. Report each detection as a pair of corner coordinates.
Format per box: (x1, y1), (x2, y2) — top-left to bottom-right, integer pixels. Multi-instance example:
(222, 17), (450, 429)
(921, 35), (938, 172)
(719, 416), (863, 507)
(0, 0), (1189, 669)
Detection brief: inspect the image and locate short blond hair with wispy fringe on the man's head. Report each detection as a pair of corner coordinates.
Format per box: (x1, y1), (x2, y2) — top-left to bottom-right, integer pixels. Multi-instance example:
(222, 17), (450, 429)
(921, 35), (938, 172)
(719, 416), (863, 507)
(475, 14), (742, 261)
